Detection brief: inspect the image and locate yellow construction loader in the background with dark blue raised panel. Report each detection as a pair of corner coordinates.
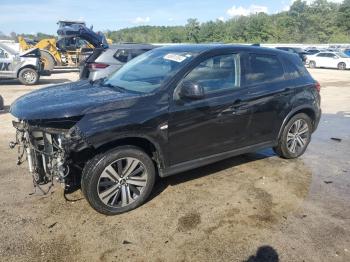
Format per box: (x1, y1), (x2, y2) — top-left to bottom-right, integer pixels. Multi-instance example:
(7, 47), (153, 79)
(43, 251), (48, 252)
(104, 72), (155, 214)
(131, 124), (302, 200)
(18, 20), (110, 72)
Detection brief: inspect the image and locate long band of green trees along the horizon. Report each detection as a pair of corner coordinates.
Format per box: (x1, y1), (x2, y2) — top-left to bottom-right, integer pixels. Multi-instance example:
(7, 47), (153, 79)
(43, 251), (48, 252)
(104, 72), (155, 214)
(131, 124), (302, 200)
(107, 0), (350, 43)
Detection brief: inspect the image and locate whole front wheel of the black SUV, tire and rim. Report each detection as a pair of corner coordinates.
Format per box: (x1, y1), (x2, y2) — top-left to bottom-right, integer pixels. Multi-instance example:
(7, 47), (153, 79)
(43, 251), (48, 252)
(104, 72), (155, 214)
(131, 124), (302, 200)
(81, 146), (156, 215)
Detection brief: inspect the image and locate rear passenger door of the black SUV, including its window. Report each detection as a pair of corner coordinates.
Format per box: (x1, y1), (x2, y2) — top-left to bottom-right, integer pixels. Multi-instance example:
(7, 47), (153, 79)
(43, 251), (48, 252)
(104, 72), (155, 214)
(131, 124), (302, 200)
(244, 53), (294, 145)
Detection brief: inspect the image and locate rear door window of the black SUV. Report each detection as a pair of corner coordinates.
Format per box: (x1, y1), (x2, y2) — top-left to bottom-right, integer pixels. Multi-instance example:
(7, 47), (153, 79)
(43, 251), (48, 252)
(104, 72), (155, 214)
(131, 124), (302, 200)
(245, 54), (284, 85)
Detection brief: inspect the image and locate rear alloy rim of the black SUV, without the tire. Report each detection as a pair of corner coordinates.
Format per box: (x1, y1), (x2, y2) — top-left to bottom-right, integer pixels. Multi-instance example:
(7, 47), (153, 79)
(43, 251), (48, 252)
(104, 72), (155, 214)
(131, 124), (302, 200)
(287, 119), (310, 154)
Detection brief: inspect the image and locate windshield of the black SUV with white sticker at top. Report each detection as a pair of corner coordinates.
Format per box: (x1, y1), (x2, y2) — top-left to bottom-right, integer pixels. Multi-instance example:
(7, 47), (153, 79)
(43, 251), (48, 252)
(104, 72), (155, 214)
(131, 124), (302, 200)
(102, 49), (196, 93)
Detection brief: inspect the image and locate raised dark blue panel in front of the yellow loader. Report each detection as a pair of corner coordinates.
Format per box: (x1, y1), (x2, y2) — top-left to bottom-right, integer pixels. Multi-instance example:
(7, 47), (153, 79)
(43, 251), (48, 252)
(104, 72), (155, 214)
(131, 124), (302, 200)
(57, 24), (109, 49)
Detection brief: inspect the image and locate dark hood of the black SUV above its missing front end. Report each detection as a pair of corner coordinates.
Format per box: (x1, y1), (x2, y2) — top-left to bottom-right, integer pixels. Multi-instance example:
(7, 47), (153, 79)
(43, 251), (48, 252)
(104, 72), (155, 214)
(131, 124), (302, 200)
(10, 81), (141, 120)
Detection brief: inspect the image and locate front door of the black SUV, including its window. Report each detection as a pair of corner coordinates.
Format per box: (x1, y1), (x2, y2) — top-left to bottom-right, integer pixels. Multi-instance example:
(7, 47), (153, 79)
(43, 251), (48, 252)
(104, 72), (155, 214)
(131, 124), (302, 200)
(168, 53), (249, 165)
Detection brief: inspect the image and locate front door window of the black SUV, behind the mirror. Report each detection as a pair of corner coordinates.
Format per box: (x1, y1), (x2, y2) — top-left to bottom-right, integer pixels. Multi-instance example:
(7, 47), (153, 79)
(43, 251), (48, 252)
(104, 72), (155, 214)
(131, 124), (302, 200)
(184, 54), (240, 94)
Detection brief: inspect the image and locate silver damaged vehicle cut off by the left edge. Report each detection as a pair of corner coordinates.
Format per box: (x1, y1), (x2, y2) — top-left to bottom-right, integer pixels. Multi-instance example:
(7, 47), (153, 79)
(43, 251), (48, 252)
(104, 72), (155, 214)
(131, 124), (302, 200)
(0, 43), (48, 85)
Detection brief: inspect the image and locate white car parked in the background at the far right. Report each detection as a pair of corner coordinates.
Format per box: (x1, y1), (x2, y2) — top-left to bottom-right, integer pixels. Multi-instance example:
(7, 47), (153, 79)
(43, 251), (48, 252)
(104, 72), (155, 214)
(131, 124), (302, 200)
(306, 52), (350, 70)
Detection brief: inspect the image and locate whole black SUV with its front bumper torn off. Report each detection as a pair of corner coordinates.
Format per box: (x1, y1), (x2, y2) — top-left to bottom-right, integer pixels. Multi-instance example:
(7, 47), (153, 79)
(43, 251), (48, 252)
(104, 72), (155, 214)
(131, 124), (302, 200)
(11, 45), (321, 215)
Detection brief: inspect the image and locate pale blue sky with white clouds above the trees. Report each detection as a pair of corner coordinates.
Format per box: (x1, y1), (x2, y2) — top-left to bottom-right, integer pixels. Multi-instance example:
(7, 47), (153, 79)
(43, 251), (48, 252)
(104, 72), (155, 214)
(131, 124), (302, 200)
(0, 0), (342, 34)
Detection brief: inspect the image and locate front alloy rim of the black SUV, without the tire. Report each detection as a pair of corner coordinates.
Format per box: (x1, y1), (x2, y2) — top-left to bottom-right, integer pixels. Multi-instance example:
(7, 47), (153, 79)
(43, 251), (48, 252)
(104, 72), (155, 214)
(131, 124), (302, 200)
(97, 157), (148, 208)
